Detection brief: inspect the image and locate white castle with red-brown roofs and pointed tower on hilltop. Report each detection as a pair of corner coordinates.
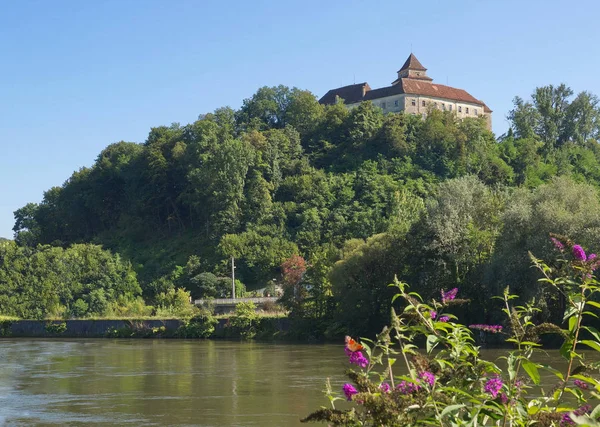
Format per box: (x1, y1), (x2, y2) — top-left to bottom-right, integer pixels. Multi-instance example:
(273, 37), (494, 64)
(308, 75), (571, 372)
(319, 53), (492, 130)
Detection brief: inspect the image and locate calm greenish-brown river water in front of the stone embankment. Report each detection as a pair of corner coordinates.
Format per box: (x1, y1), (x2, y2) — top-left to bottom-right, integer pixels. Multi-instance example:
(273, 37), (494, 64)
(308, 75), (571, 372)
(0, 339), (576, 427)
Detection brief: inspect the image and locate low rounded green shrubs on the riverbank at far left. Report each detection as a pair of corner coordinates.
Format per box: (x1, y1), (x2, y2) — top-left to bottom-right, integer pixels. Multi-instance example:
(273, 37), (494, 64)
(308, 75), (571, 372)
(0, 242), (141, 319)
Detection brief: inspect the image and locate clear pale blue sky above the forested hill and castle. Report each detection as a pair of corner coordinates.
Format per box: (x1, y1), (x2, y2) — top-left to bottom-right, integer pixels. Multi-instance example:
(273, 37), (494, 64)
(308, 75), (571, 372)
(0, 0), (600, 238)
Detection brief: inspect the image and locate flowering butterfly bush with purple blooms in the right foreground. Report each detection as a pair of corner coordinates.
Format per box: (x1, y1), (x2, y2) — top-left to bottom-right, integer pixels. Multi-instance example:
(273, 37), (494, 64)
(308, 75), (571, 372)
(302, 244), (600, 427)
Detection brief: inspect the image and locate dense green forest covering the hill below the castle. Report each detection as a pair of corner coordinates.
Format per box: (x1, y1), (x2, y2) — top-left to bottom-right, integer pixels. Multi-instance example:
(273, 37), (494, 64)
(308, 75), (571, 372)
(5, 85), (600, 336)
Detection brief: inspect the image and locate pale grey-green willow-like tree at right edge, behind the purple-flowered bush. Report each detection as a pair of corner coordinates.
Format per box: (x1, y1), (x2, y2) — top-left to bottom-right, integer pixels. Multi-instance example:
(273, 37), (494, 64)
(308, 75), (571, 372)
(487, 177), (600, 315)
